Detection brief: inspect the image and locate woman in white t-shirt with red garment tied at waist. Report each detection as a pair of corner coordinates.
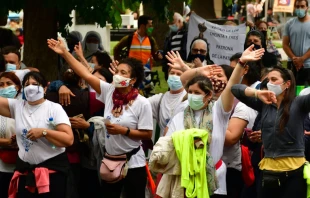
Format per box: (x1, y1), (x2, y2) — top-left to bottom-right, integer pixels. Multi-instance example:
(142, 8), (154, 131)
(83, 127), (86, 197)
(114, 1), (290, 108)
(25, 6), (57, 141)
(0, 72), (73, 198)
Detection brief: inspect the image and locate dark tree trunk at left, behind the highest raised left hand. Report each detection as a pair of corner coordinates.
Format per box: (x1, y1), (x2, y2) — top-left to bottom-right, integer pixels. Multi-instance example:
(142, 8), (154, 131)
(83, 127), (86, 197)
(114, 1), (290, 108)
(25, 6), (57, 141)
(23, 0), (58, 80)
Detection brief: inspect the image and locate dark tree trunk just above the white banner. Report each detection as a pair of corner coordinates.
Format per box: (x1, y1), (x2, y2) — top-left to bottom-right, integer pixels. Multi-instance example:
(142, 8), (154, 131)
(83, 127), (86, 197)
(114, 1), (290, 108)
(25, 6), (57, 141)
(191, 0), (216, 19)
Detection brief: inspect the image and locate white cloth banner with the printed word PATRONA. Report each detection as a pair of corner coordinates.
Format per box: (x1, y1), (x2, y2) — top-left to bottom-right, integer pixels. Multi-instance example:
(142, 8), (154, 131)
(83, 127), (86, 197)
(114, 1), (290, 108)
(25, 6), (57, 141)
(187, 13), (246, 65)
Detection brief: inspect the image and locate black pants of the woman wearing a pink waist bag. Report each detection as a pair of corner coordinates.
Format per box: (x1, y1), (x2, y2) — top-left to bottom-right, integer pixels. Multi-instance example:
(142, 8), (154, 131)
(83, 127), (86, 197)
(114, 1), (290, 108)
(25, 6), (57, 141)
(101, 167), (146, 198)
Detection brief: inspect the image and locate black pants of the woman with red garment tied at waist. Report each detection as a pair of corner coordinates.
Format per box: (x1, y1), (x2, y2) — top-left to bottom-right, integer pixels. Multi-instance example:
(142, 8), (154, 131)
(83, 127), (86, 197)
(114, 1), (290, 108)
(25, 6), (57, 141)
(17, 172), (67, 198)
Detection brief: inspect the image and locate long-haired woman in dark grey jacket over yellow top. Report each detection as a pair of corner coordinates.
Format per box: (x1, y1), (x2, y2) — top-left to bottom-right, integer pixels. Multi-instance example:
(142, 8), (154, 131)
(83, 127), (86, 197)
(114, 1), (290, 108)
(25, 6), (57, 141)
(231, 67), (310, 198)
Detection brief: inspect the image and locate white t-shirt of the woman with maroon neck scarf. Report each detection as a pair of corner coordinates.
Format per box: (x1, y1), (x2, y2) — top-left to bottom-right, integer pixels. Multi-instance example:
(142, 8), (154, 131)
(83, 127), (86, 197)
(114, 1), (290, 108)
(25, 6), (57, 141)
(97, 81), (153, 168)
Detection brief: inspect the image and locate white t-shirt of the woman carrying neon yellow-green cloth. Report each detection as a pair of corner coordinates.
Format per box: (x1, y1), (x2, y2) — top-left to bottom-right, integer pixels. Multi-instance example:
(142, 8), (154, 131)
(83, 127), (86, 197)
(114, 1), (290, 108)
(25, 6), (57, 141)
(167, 97), (230, 195)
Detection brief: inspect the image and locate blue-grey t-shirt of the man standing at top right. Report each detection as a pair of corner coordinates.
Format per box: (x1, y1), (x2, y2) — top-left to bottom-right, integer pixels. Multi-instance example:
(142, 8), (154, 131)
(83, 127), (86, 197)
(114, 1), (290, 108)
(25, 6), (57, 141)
(283, 17), (310, 68)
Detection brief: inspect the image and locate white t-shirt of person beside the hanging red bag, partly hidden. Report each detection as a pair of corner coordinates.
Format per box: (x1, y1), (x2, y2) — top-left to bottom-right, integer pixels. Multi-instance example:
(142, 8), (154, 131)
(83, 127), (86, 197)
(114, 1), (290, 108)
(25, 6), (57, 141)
(222, 102), (257, 171)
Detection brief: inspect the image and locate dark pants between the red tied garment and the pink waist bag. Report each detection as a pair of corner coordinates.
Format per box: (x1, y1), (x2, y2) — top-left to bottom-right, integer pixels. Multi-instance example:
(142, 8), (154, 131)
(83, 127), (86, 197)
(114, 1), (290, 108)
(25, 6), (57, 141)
(79, 168), (103, 198)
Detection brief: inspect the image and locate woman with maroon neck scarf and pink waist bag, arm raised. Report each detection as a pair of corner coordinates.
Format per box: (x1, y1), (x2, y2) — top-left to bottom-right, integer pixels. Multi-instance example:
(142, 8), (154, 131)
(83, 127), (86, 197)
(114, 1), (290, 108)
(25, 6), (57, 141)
(48, 39), (153, 198)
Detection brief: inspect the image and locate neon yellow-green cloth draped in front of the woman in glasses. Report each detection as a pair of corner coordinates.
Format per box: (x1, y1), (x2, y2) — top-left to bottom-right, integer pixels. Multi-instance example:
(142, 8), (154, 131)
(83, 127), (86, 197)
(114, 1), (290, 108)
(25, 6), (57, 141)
(172, 128), (209, 198)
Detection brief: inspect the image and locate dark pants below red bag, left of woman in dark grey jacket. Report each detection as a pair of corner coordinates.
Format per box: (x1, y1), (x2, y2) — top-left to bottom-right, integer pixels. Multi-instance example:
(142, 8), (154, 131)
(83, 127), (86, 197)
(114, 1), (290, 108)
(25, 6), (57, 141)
(226, 168), (243, 198)
